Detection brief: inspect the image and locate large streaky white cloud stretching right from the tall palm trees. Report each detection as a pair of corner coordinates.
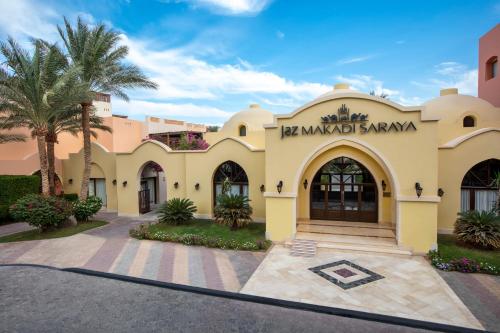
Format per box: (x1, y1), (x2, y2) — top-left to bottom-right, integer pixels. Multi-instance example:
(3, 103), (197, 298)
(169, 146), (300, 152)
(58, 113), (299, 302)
(122, 35), (330, 101)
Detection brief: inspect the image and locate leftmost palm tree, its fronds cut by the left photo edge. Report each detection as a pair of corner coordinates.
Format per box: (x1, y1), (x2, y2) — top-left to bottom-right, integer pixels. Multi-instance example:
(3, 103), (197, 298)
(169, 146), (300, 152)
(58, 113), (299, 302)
(0, 37), (88, 195)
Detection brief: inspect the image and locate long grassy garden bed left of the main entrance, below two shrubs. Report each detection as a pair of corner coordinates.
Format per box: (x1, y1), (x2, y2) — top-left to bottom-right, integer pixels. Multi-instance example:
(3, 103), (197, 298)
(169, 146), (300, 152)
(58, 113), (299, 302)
(130, 219), (271, 251)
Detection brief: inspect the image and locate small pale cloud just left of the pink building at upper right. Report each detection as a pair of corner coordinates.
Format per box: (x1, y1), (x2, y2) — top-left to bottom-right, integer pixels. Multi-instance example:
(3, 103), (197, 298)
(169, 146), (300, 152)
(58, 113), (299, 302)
(411, 61), (478, 96)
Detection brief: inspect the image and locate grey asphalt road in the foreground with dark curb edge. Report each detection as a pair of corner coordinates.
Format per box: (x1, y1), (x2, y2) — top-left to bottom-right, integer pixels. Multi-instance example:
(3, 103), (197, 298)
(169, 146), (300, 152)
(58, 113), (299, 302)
(0, 267), (436, 333)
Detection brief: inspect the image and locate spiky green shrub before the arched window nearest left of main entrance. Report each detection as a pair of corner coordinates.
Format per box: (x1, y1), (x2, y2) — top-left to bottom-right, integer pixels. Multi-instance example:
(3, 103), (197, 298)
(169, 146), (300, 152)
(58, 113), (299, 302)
(214, 194), (252, 230)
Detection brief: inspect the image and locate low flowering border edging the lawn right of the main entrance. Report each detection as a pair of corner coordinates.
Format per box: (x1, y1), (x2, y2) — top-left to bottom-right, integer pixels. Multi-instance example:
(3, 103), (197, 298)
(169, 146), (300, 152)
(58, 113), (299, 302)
(427, 250), (500, 275)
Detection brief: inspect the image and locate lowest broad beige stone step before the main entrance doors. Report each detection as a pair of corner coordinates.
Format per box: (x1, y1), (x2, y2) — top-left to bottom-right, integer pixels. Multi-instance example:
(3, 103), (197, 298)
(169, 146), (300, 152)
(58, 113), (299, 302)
(292, 232), (412, 255)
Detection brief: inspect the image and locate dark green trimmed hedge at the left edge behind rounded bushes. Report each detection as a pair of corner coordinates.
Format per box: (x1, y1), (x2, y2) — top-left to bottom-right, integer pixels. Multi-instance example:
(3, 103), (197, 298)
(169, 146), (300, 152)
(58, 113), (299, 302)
(0, 175), (40, 224)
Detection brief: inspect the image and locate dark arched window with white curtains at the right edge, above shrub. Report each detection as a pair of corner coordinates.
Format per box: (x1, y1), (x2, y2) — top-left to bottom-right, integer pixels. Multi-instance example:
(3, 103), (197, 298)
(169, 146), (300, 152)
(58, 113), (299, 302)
(460, 158), (500, 212)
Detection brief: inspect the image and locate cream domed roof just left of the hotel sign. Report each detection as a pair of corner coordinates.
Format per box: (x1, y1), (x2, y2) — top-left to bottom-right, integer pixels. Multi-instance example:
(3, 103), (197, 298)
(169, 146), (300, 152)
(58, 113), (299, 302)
(221, 104), (274, 133)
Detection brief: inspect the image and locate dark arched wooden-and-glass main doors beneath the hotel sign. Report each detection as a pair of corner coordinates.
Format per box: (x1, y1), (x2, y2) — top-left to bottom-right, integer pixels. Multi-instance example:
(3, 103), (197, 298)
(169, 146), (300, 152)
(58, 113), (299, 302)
(310, 156), (378, 223)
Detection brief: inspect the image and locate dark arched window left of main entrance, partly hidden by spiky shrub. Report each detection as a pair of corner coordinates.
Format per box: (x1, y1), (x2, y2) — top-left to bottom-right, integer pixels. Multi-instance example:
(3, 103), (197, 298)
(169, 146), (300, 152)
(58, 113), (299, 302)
(214, 161), (248, 204)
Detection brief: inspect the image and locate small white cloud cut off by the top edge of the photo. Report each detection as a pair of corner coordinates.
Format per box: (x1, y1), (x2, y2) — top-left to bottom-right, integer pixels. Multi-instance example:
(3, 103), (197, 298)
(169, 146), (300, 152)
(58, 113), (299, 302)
(177, 0), (270, 15)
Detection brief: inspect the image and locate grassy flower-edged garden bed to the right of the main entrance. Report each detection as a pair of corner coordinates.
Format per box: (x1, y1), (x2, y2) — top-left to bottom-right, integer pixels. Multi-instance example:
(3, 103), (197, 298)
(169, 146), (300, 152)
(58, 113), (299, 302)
(429, 235), (500, 275)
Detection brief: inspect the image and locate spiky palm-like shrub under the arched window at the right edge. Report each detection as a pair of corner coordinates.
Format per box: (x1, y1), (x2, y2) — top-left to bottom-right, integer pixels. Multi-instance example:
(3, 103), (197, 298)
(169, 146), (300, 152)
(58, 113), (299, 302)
(454, 210), (500, 249)
